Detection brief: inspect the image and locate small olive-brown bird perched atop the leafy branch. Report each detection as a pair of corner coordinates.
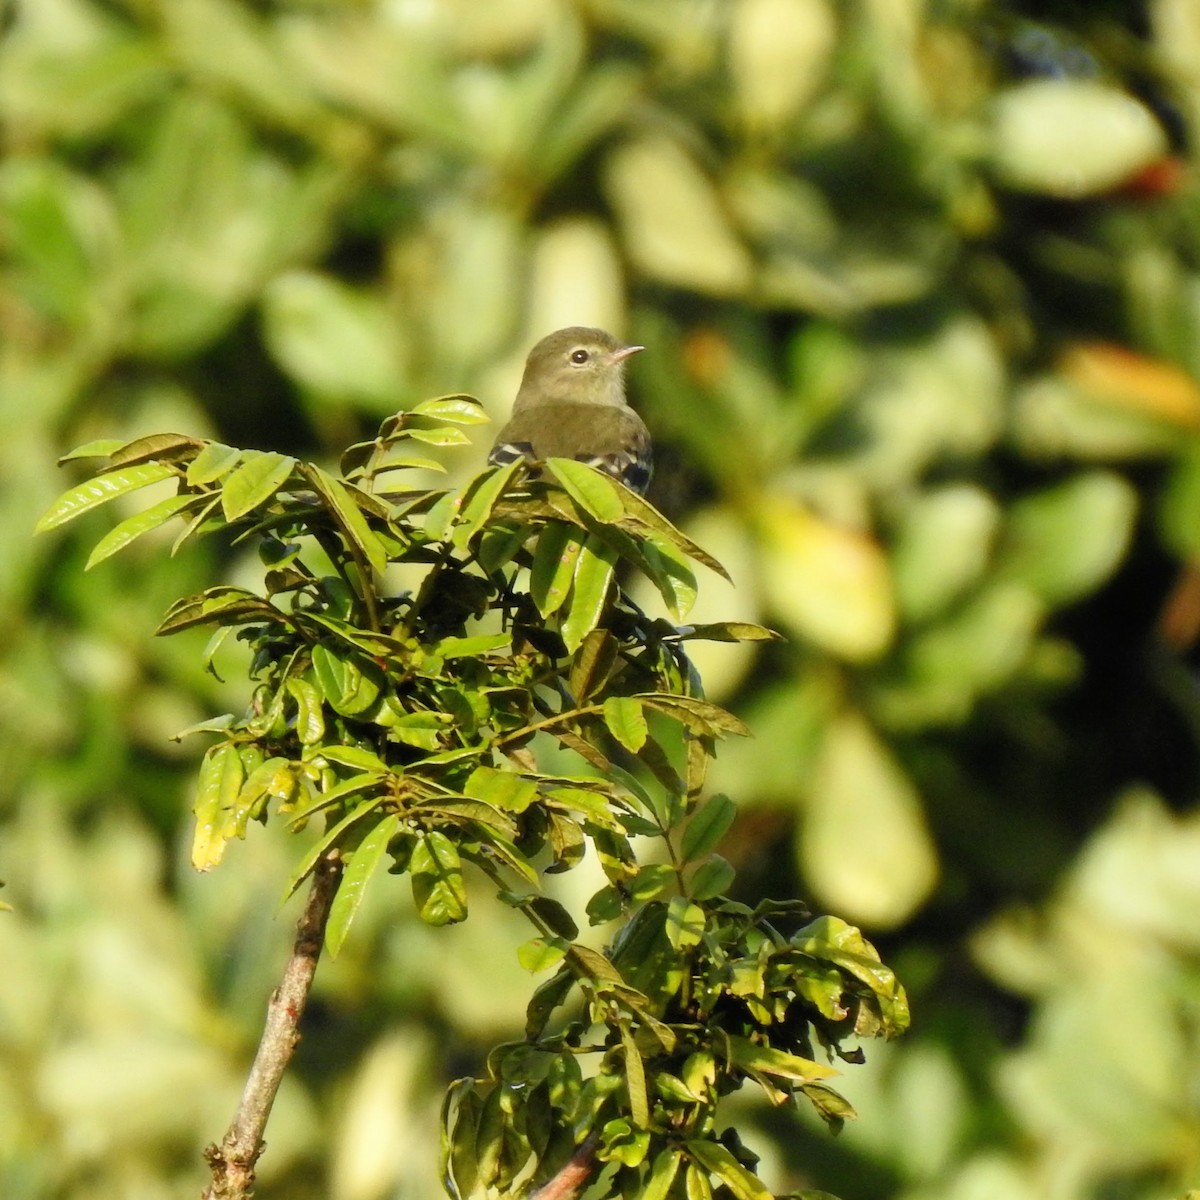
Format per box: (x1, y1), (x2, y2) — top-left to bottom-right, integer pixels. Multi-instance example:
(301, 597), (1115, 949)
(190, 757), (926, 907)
(487, 325), (652, 494)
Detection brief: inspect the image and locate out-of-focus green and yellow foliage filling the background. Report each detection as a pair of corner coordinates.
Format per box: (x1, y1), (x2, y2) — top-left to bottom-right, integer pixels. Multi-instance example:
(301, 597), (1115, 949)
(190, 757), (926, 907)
(7, 0), (1200, 1200)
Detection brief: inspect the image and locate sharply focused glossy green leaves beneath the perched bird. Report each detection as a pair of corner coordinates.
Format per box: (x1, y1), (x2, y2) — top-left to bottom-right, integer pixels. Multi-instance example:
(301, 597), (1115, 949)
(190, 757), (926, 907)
(38, 420), (908, 1200)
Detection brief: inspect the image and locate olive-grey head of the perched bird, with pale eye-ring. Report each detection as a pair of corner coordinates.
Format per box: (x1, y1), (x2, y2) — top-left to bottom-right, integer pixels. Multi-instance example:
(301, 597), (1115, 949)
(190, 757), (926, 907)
(514, 325), (643, 410)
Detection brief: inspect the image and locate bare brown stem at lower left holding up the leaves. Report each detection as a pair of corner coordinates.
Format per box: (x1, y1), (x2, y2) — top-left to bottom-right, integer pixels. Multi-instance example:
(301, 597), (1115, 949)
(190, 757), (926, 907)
(203, 851), (342, 1200)
